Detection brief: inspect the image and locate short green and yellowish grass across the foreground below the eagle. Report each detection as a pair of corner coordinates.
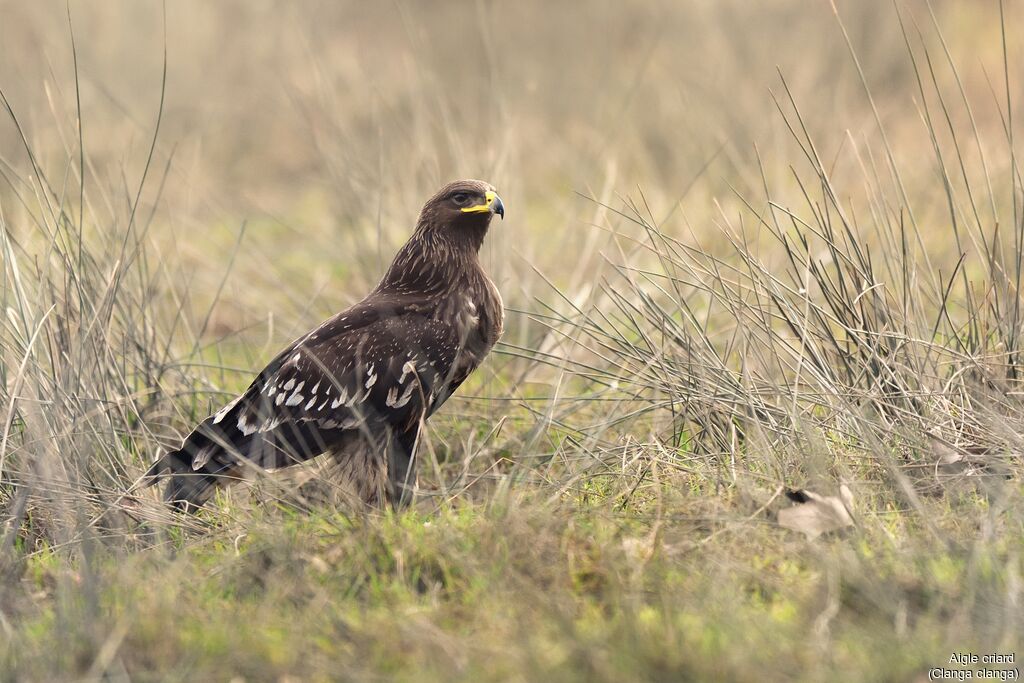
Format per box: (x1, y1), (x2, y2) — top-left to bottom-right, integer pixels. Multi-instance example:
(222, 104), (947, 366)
(5, 486), (1024, 681)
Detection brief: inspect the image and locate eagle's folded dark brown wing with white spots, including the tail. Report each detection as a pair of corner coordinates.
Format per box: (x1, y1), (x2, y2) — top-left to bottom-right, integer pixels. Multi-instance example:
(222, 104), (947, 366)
(146, 300), (472, 505)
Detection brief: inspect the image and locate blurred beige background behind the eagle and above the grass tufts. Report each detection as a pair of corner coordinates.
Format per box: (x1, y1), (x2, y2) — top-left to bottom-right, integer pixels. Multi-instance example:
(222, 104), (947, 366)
(0, 0), (1021, 337)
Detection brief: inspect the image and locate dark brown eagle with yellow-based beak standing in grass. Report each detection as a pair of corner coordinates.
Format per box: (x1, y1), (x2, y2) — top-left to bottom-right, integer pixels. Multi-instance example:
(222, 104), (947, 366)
(142, 180), (505, 512)
